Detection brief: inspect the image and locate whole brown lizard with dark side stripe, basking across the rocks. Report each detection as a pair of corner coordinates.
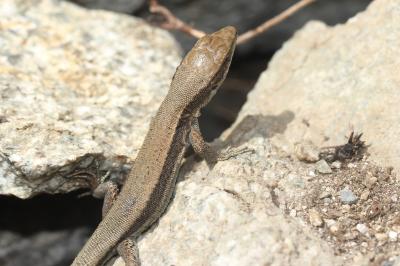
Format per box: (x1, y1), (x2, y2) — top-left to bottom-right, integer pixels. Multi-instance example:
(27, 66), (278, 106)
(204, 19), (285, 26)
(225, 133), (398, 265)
(72, 26), (236, 266)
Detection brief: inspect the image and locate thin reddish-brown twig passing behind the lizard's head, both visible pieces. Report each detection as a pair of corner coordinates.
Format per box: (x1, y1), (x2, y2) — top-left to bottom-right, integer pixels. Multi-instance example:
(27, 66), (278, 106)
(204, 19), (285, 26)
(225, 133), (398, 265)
(149, 0), (316, 44)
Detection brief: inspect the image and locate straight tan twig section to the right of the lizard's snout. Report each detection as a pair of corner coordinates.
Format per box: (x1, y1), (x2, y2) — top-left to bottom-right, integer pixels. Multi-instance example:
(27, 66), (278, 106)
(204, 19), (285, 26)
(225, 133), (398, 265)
(237, 0), (316, 44)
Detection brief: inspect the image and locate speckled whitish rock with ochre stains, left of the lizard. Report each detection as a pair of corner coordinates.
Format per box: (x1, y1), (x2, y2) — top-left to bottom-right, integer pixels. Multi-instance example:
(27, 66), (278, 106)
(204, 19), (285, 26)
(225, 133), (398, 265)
(0, 0), (180, 198)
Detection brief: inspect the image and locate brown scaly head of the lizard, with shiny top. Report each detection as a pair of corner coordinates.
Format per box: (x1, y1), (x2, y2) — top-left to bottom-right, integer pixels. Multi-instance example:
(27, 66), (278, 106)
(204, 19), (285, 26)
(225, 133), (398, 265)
(169, 26), (237, 114)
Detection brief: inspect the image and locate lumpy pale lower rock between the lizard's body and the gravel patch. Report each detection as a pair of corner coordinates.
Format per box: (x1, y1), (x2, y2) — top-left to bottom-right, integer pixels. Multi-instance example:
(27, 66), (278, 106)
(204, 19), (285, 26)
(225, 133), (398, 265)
(114, 137), (343, 266)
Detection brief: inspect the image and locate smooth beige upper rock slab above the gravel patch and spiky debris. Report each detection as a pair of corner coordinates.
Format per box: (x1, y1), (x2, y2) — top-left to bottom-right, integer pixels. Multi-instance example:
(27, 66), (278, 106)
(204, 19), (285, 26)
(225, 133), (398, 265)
(237, 0), (400, 175)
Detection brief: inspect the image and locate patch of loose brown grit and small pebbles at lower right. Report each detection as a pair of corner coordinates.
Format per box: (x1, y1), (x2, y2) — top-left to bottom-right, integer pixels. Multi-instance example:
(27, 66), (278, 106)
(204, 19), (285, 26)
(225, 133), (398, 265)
(286, 149), (400, 265)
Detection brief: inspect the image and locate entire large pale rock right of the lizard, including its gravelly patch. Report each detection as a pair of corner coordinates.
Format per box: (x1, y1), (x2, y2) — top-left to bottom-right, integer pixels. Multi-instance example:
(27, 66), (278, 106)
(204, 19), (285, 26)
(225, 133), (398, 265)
(116, 0), (400, 265)
